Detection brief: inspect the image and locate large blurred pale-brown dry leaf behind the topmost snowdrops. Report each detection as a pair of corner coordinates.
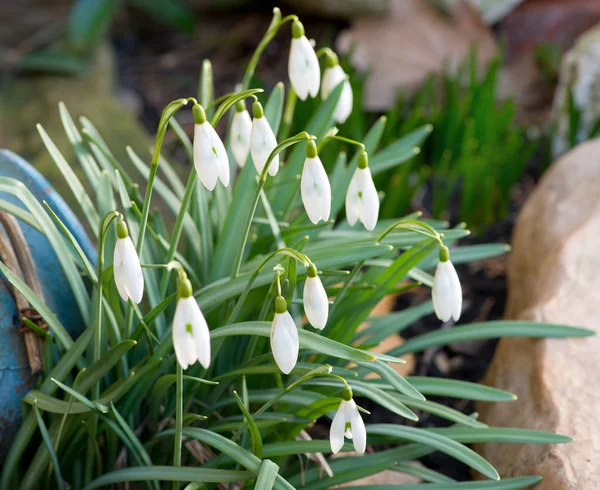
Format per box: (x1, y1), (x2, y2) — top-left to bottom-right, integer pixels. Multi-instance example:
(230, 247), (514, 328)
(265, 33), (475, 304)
(337, 0), (496, 110)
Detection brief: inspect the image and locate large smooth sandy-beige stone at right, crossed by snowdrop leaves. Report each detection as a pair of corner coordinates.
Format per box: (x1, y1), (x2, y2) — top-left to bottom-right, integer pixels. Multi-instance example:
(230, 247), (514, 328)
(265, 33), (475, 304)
(477, 139), (600, 490)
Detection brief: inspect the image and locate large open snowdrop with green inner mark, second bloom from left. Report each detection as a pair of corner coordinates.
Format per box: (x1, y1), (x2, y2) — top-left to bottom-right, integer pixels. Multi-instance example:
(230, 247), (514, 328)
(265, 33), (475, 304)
(173, 278), (210, 369)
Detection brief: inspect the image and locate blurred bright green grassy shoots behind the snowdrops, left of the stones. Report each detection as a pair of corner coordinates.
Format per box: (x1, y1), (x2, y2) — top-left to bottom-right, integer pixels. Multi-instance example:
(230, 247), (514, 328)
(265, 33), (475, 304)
(346, 51), (537, 230)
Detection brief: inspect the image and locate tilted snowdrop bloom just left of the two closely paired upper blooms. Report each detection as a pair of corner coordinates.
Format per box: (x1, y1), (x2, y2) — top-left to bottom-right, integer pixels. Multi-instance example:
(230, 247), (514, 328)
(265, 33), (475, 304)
(192, 104), (229, 191)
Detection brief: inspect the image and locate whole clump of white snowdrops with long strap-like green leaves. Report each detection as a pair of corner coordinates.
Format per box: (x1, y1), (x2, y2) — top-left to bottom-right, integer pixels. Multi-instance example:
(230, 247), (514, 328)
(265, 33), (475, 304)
(0, 9), (588, 490)
